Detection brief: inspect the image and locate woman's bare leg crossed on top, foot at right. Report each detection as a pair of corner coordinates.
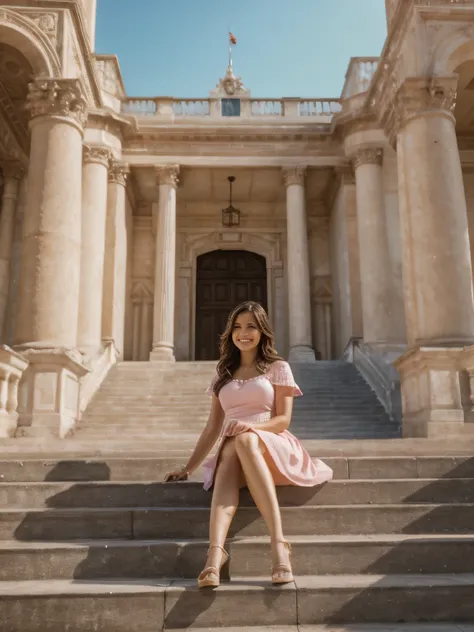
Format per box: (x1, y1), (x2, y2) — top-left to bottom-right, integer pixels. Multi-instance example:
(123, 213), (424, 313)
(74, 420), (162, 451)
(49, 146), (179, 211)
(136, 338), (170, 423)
(235, 432), (289, 565)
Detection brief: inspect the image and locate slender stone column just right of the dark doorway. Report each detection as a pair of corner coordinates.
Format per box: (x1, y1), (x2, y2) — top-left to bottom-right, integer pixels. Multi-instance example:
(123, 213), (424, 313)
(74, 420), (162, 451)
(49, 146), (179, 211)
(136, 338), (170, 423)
(283, 167), (315, 362)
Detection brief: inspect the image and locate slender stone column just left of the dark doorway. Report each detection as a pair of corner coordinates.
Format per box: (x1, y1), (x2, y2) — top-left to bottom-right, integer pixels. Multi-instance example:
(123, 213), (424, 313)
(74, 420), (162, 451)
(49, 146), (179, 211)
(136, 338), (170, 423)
(150, 165), (179, 361)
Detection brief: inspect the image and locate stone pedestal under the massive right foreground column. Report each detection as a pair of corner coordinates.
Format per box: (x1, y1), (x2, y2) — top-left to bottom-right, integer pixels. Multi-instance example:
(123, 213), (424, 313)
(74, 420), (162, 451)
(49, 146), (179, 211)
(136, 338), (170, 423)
(394, 347), (466, 438)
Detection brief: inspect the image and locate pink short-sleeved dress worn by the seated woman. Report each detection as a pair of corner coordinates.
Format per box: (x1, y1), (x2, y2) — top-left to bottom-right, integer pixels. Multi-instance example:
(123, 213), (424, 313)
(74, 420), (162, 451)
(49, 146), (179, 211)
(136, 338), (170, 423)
(203, 360), (333, 490)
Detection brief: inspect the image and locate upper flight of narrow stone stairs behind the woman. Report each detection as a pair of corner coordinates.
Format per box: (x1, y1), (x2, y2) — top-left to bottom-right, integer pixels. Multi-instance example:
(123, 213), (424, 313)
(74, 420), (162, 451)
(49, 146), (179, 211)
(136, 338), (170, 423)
(75, 361), (400, 450)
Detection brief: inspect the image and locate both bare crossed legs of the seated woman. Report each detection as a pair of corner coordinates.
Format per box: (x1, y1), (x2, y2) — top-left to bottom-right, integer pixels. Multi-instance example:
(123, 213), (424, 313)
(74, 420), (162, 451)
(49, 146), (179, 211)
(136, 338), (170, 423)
(206, 432), (289, 568)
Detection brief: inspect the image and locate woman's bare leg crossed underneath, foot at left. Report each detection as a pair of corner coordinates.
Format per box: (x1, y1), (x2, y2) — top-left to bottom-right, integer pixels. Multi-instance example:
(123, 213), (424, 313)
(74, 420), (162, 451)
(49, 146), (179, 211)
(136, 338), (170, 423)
(206, 438), (243, 568)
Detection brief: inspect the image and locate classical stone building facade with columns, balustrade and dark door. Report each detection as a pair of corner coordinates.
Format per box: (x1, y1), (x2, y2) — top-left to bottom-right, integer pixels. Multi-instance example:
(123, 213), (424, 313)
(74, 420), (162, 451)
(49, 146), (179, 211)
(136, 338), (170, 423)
(0, 0), (474, 436)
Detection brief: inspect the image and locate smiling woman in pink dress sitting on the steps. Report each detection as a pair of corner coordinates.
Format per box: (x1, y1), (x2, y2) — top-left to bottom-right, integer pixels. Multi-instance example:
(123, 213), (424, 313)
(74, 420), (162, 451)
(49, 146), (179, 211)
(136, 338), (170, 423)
(165, 302), (332, 588)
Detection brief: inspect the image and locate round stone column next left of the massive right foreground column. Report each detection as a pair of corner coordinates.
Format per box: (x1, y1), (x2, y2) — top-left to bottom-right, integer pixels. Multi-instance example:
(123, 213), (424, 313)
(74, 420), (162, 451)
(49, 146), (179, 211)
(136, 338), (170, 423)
(352, 147), (395, 345)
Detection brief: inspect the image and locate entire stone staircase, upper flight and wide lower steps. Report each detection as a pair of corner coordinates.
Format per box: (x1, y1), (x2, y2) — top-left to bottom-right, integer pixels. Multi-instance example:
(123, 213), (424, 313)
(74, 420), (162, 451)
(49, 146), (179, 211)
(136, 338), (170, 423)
(0, 363), (474, 632)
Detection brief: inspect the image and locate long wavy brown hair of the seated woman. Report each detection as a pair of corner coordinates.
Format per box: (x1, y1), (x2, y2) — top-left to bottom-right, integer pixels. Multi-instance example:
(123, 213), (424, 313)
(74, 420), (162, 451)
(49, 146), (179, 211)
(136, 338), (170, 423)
(214, 301), (282, 396)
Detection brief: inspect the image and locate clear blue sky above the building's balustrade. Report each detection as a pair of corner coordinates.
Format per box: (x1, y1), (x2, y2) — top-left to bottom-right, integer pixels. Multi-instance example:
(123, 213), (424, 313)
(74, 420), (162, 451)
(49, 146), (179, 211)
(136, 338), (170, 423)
(96, 0), (386, 98)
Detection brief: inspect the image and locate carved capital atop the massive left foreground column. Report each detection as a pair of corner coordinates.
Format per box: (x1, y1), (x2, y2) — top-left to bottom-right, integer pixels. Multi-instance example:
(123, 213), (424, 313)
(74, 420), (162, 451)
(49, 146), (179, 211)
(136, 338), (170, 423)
(27, 79), (87, 130)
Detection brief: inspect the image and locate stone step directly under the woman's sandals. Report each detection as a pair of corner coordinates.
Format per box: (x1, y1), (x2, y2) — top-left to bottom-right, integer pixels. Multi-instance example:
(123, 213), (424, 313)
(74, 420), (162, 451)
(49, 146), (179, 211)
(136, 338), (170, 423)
(0, 574), (474, 632)
